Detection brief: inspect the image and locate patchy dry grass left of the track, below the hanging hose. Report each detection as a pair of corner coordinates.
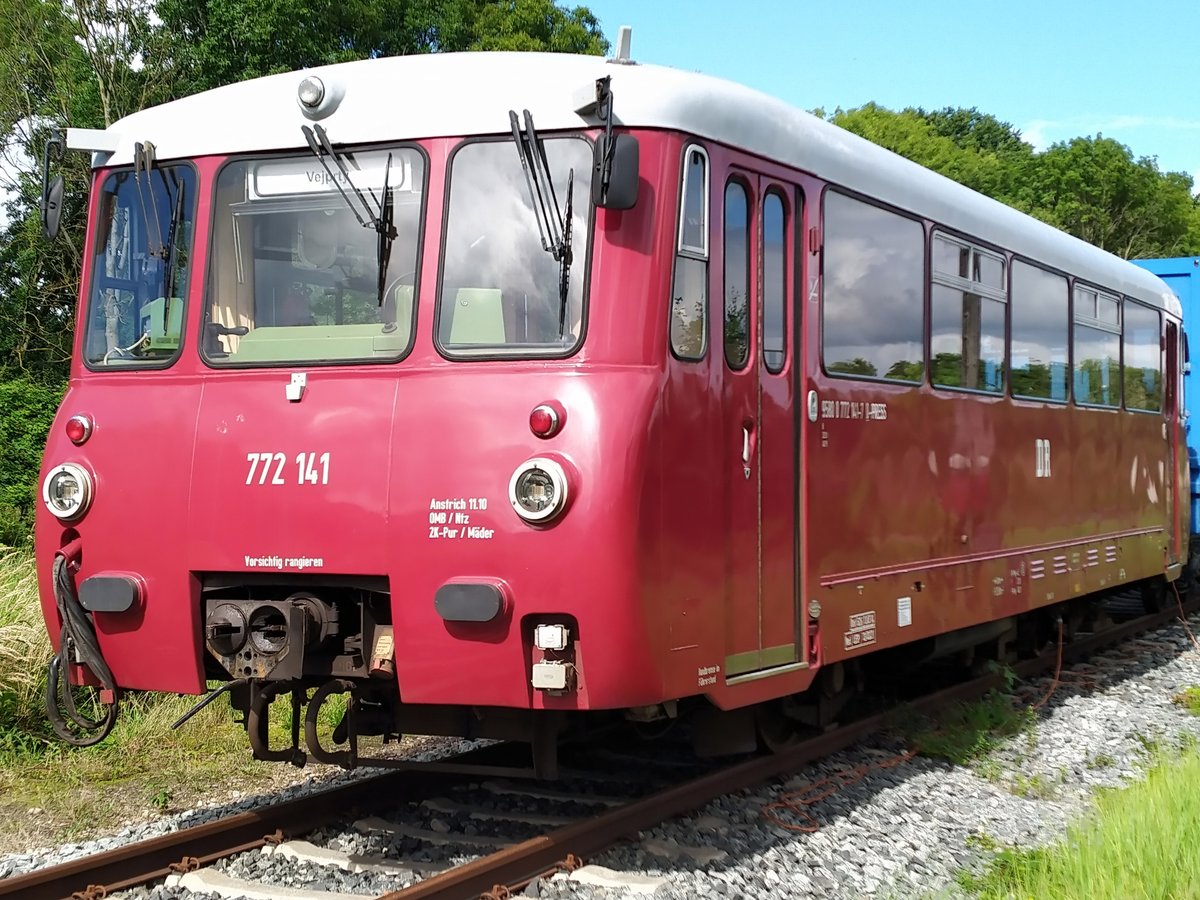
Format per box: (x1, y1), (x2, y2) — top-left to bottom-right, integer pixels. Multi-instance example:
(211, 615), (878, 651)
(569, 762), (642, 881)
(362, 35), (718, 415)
(0, 547), (319, 853)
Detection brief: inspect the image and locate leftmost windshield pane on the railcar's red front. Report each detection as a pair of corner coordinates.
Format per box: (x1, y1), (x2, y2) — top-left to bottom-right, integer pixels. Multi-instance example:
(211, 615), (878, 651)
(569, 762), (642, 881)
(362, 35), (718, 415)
(83, 166), (196, 368)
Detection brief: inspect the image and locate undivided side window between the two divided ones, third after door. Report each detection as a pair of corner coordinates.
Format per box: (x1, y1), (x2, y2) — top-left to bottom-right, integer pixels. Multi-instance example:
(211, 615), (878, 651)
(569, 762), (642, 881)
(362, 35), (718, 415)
(1008, 262), (1070, 401)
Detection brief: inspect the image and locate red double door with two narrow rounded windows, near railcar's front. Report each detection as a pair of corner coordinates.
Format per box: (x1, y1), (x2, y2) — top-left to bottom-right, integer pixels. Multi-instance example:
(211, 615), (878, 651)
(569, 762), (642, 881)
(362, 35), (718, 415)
(713, 169), (805, 679)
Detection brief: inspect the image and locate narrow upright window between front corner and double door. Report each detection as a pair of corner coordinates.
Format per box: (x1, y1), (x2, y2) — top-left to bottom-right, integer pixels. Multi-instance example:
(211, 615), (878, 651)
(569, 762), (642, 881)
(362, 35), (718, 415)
(671, 146), (708, 360)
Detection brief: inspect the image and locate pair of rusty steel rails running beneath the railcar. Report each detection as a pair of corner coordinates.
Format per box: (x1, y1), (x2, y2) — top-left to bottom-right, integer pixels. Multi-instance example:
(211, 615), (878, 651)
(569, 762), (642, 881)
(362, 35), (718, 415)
(0, 601), (1200, 900)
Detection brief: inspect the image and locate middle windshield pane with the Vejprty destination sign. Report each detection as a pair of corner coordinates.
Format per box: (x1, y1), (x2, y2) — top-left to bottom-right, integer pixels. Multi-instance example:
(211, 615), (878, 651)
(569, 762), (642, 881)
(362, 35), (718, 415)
(203, 148), (425, 365)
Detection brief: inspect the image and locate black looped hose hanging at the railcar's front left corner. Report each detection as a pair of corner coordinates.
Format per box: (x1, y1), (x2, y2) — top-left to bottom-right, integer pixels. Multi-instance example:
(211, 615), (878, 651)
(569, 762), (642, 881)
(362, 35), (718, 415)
(46, 553), (118, 746)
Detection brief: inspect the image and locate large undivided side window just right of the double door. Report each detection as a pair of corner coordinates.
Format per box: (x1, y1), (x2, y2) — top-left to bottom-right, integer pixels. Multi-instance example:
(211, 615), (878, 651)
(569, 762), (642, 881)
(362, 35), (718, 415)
(821, 191), (925, 382)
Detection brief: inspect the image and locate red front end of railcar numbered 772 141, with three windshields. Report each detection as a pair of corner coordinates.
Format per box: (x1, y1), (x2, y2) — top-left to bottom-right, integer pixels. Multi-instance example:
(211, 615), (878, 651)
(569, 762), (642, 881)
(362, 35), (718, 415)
(37, 58), (700, 764)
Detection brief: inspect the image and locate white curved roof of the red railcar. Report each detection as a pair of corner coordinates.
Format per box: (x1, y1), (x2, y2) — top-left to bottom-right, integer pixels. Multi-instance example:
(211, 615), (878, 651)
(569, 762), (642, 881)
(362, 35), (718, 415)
(88, 53), (1181, 316)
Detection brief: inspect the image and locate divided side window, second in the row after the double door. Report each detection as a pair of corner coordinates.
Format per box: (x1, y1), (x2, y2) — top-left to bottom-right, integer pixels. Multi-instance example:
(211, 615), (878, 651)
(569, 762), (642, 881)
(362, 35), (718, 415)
(930, 234), (1007, 394)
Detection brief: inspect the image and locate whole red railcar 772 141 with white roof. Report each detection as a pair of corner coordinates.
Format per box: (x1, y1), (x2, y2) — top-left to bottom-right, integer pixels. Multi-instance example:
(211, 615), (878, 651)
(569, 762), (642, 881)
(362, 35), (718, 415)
(37, 45), (1187, 764)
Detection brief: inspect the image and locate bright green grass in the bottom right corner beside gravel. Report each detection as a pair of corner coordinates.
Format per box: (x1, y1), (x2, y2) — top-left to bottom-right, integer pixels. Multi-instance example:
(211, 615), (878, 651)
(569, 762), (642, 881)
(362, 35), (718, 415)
(959, 750), (1200, 900)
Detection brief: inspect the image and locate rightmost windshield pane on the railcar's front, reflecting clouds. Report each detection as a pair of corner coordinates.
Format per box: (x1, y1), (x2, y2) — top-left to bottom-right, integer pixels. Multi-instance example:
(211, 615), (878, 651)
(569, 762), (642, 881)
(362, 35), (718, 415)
(438, 138), (592, 356)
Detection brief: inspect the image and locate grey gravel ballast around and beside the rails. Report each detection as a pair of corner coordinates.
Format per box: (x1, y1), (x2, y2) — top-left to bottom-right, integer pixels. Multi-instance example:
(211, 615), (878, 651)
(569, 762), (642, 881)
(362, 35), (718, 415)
(0, 617), (1200, 900)
